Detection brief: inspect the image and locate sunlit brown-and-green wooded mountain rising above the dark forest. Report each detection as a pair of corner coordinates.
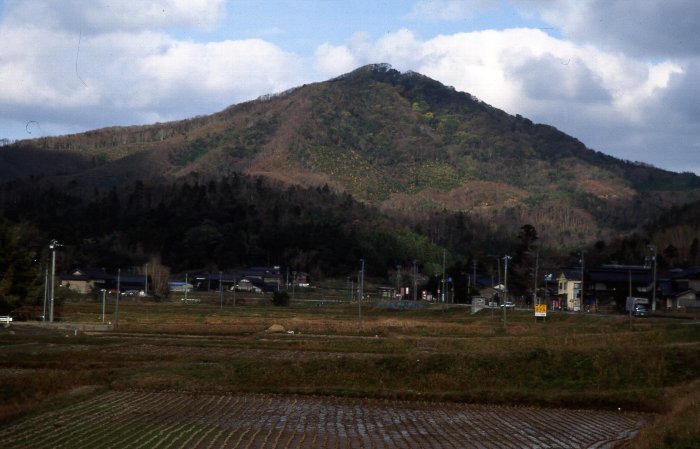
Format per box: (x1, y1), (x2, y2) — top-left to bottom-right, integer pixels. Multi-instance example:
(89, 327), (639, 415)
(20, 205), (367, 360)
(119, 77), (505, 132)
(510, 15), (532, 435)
(0, 64), (700, 247)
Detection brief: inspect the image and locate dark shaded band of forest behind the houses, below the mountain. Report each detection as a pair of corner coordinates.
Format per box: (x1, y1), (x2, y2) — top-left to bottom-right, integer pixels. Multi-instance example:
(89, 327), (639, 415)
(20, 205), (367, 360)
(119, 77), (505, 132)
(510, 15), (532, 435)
(0, 176), (438, 276)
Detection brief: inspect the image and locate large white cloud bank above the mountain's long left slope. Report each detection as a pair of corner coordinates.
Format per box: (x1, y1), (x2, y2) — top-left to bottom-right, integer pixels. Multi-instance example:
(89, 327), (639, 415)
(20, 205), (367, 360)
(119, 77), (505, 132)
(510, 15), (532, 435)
(0, 0), (306, 138)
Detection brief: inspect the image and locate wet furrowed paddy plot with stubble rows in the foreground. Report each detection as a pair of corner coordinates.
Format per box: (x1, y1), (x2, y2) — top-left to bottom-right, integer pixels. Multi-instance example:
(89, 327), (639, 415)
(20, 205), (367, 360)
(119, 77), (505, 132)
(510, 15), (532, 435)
(0, 391), (645, 449)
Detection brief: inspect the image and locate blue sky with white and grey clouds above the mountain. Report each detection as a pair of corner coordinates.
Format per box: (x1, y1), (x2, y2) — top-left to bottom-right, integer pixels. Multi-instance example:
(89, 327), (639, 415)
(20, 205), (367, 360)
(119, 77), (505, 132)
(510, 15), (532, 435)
(0, 0), (700, 174)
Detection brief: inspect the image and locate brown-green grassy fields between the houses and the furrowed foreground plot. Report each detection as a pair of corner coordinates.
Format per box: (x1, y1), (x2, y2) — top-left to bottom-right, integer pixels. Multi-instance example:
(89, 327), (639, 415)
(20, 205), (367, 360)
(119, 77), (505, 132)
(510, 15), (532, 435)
(0, 299), (700, 447)
